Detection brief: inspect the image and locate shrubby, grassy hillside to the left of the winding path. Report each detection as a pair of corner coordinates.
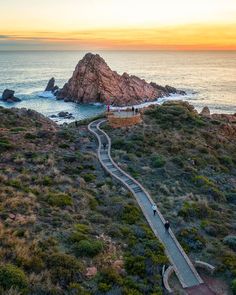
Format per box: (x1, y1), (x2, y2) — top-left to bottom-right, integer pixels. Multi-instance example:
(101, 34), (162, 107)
(0, 108), (167, 295)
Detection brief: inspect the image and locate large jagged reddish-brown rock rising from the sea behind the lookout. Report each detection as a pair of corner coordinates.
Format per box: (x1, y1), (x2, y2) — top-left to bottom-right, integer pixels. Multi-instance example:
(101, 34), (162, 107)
(57, 53), (185, 106)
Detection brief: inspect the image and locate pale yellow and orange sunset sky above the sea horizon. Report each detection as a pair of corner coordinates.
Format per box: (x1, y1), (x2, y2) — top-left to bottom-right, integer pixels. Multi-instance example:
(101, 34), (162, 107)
(0, 0), (236, 50)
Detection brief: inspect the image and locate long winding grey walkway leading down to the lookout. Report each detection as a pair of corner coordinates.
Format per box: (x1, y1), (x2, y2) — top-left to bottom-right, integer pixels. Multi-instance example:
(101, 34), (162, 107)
(88, 119), (203, 294)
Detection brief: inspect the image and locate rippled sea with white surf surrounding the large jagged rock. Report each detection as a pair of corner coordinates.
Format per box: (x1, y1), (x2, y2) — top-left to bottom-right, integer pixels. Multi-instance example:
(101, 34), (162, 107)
(0, 51), (236, 123)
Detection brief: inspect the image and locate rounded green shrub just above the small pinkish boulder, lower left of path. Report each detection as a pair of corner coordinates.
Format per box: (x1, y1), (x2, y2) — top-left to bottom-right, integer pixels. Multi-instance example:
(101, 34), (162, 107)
(73, 240), (103, 257)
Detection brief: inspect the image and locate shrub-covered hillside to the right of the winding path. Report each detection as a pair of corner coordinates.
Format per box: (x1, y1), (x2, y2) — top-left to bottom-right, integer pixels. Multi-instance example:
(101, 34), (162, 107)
(105, 102), (236, 294)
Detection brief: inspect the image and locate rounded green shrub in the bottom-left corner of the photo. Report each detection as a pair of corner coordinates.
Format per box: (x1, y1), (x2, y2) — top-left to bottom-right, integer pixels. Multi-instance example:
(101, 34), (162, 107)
(0, 264), (28, 294)
